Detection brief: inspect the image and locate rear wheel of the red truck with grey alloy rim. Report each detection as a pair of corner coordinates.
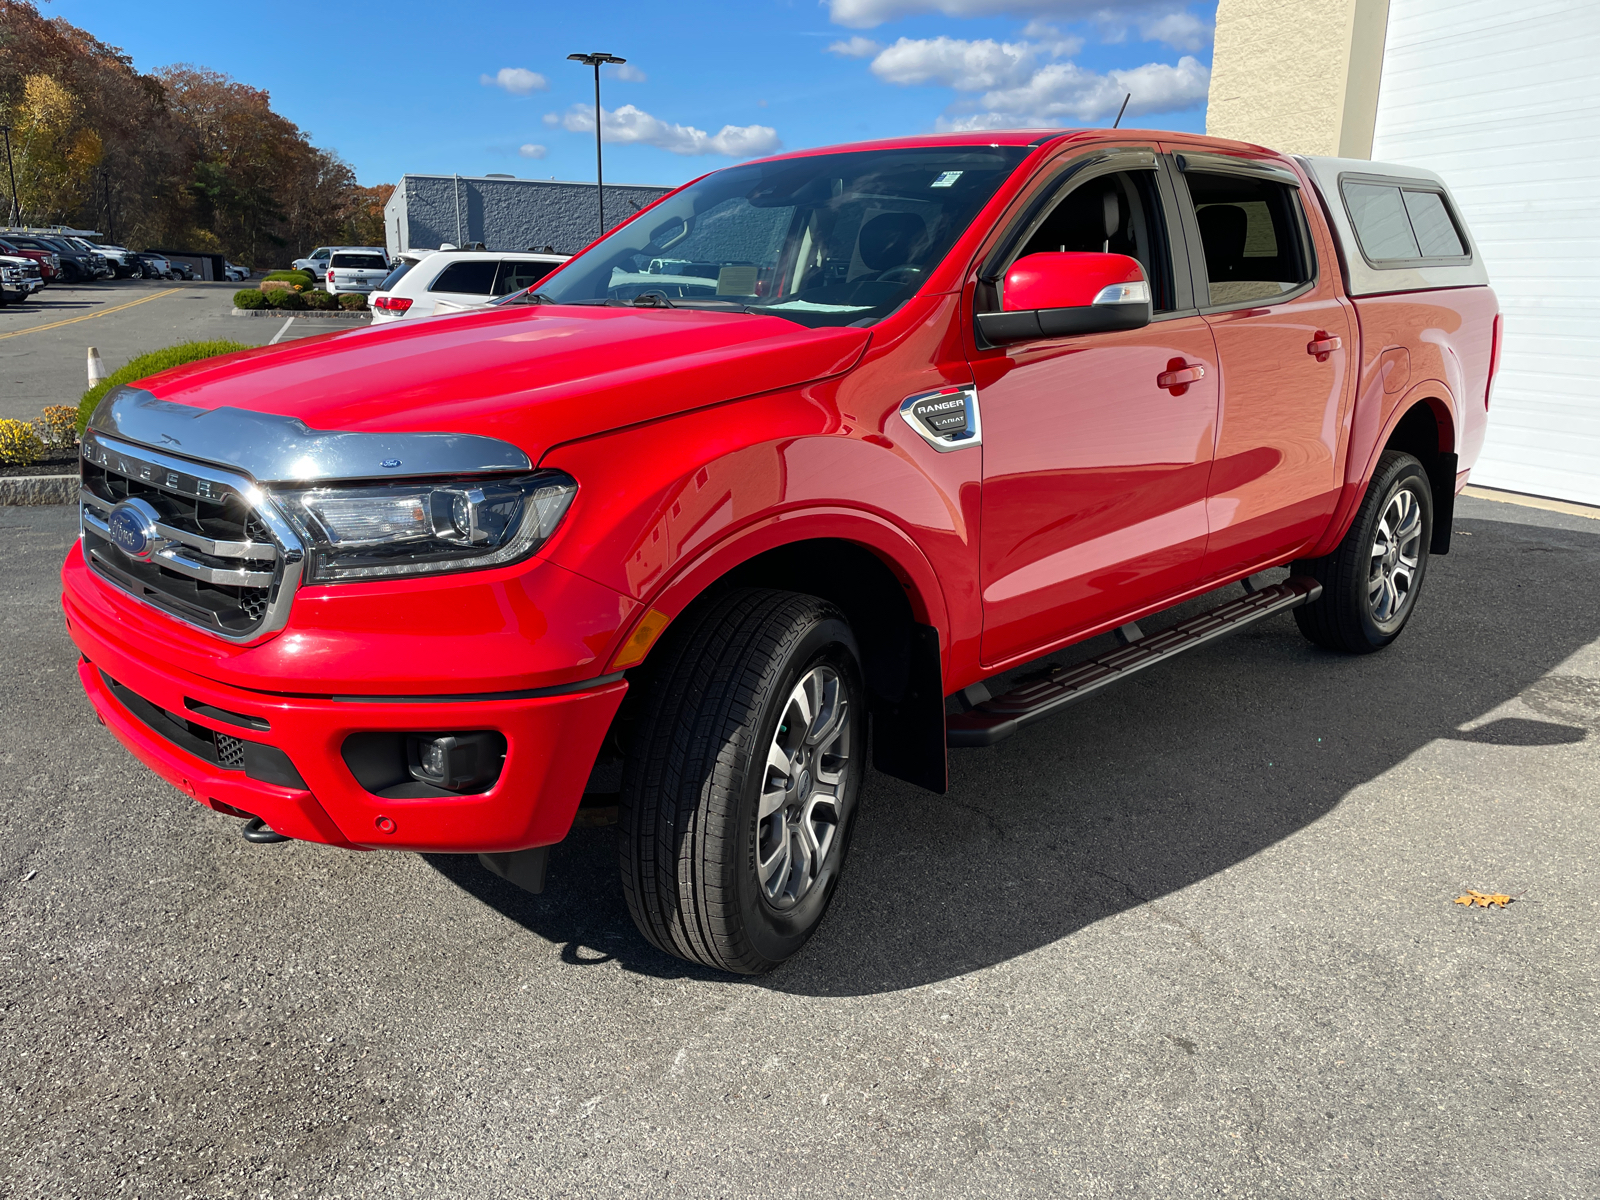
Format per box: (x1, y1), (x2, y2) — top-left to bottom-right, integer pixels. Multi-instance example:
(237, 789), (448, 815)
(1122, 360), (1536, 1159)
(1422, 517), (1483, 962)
(1293, 450), (1434, 654)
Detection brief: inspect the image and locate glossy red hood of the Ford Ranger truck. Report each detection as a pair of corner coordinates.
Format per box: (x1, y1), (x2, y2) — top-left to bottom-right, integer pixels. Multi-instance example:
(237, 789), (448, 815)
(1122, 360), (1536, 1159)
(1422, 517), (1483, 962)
(138, 306), (870, 462)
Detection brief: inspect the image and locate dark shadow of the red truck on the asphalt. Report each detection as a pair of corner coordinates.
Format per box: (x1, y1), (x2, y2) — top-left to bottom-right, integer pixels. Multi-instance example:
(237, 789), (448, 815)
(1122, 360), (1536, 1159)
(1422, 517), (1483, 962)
(427, 506), (1600, 995)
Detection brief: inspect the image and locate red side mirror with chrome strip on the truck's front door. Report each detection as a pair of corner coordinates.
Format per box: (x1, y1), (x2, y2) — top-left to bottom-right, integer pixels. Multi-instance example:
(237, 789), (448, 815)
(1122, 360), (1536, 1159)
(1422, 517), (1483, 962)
(978, 253), (1150, 346)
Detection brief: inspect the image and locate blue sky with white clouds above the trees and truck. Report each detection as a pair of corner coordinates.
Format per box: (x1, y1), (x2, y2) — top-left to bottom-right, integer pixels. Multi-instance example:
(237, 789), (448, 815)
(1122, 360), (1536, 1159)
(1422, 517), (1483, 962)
(53, 0), (1216, 184)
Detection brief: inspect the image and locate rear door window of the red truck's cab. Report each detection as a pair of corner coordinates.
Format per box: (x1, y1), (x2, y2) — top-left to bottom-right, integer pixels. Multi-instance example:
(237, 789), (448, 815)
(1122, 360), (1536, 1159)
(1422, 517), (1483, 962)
(1184, 171), (1312, 307)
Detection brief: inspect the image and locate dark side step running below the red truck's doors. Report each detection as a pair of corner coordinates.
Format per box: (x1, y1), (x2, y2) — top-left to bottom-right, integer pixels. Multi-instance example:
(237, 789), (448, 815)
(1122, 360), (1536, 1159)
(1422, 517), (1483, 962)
(946, 574), (1322, 746)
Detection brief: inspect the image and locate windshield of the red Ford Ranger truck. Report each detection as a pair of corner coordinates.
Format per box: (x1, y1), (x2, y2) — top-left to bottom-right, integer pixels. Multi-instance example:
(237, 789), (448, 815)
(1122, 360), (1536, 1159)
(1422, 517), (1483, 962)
(539, 146), (1027, 326)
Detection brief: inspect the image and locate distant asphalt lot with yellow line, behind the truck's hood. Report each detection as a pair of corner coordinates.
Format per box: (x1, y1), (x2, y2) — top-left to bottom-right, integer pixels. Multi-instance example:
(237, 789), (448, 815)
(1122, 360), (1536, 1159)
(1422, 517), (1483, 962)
(0, 278), (368, 421)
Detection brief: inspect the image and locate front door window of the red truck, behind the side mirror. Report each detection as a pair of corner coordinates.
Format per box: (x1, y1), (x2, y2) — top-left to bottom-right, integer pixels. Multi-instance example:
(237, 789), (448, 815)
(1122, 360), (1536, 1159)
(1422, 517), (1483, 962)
(997, 171), (1178, 312)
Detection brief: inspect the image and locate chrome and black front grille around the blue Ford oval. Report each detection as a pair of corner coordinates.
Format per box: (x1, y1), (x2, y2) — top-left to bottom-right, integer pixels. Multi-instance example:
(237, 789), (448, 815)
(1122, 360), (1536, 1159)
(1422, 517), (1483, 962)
(78, 430), (302, 642)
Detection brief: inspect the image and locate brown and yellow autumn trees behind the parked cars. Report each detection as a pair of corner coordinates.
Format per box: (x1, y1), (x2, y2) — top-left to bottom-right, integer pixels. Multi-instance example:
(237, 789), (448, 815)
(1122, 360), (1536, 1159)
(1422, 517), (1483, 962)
(0, 0), (387, 267)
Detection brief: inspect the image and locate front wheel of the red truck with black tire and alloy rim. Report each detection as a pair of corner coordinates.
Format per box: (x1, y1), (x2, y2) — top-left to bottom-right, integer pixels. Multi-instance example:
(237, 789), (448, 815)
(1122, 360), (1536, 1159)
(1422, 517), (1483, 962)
(618, 589), (867, 974)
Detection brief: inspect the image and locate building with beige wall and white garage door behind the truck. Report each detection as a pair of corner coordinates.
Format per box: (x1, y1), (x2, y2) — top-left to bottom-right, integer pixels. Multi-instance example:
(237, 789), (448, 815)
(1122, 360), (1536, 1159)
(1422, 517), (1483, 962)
(1206, 0), (1600, 504)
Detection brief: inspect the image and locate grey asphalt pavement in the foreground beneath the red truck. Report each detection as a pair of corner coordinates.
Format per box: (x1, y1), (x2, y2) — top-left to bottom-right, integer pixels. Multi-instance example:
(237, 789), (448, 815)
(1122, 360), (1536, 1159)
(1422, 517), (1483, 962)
(0, 492), (1600, 1200)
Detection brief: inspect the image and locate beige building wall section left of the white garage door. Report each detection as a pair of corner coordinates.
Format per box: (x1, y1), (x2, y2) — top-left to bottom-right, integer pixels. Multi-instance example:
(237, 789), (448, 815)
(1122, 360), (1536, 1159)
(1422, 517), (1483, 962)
(1205, 0), (1389, 158)
